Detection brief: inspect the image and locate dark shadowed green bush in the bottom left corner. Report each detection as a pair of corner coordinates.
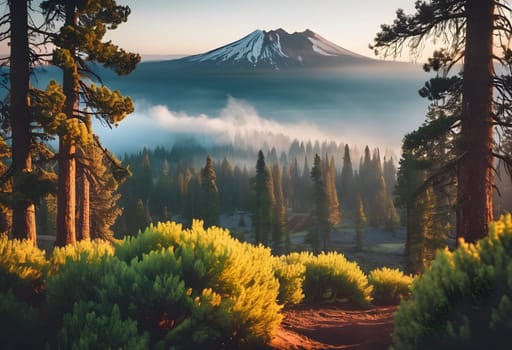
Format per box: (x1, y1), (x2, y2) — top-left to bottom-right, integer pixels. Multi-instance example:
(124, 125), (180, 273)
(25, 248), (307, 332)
(0, 291), (44, 350)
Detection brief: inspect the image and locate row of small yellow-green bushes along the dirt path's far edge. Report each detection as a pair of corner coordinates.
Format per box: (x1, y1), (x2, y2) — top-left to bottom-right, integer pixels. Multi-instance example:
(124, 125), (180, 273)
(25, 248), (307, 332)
(274, 253), (412, 307)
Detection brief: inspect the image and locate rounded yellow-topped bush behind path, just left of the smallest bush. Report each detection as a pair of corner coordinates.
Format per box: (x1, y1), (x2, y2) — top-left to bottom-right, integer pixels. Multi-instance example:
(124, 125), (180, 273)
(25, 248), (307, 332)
(303, 253), (372, 307)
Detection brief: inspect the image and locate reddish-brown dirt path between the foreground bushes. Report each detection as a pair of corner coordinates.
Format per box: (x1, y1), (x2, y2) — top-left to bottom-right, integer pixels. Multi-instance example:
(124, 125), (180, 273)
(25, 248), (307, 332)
(270, 306), (397, 350)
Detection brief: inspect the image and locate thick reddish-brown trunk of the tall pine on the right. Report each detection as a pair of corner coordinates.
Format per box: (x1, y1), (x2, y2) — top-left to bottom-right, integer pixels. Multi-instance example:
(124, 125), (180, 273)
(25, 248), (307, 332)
(457, 0), (494, 242)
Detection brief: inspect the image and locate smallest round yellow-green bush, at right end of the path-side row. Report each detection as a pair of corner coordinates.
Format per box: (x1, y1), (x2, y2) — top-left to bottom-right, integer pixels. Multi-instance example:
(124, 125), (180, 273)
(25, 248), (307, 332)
(368, 267), (413, 305)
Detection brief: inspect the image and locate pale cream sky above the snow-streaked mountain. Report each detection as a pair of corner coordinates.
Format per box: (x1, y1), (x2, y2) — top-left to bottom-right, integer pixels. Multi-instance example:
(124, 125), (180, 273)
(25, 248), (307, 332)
(104, 0), (420, 56)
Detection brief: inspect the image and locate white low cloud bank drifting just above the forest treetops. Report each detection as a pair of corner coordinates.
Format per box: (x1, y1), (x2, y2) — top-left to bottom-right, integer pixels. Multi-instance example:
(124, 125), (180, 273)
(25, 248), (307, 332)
(95, 96), (399, 154)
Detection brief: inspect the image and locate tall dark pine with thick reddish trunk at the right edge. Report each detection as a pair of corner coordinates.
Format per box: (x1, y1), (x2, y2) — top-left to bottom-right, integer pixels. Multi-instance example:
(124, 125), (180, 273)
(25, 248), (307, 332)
(374, 0), (512, 242)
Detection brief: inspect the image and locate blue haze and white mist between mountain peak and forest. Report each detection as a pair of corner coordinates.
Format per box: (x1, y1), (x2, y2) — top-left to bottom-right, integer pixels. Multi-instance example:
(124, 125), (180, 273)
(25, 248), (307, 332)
(75, 61), (429, 153)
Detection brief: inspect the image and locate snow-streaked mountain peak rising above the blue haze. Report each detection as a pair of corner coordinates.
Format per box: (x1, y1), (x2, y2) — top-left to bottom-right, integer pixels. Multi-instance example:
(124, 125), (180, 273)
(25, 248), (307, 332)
(184, 28), (371, 69)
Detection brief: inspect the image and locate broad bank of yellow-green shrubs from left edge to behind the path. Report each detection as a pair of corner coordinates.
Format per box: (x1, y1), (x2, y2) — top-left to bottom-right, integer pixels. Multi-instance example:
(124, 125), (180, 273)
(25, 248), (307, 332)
(0, 221), (416, 349)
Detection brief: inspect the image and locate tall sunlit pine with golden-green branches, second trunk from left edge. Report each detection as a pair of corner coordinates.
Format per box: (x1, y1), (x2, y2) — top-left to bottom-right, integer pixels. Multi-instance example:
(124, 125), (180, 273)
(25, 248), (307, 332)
(41, 0), (140, 246)
